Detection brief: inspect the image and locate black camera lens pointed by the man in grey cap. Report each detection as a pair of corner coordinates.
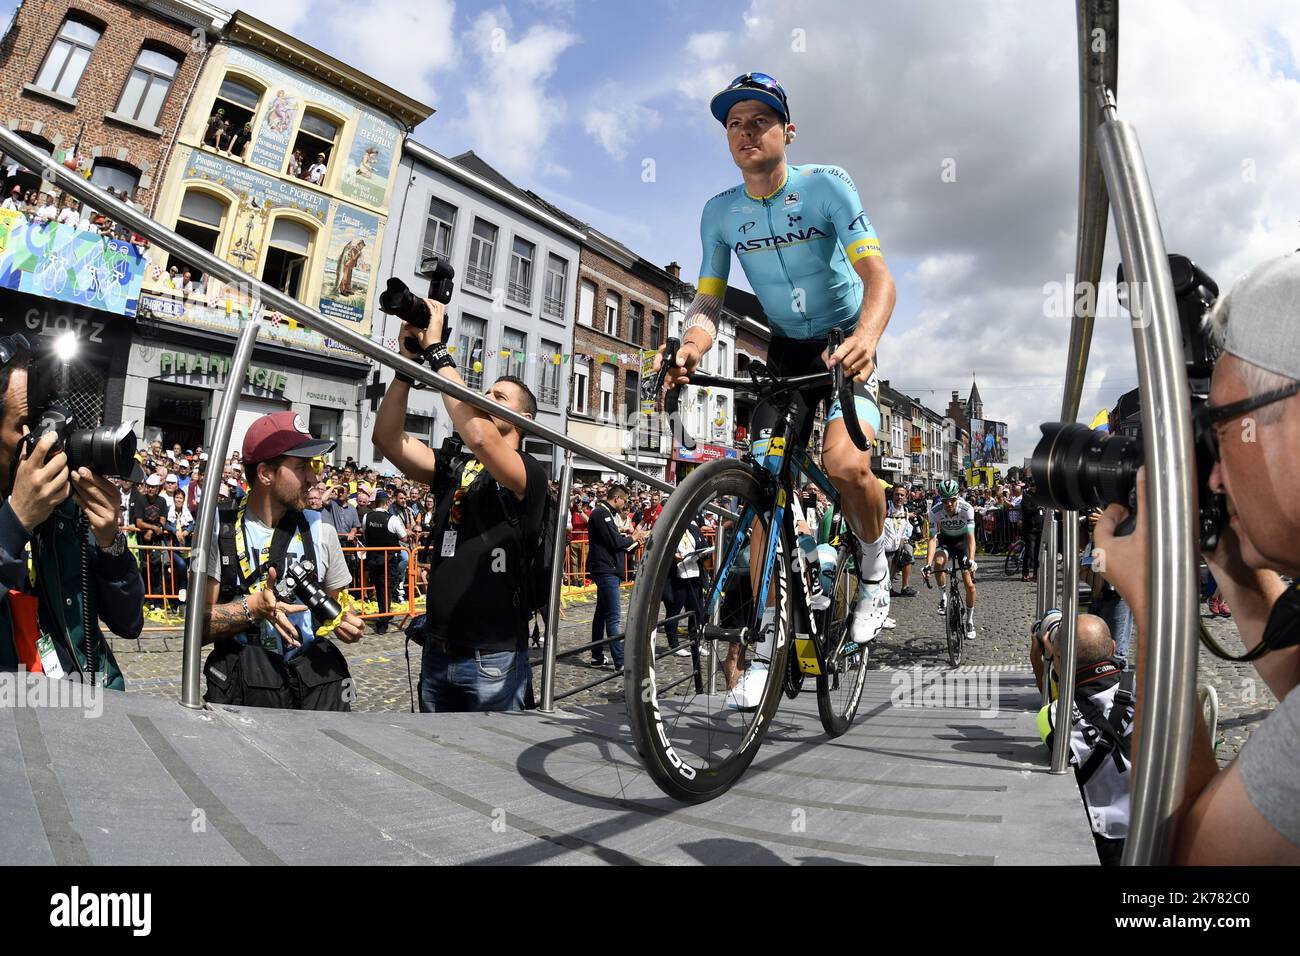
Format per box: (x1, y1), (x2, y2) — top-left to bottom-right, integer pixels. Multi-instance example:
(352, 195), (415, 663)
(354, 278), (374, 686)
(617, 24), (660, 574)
(1030, 421), (1143, 511)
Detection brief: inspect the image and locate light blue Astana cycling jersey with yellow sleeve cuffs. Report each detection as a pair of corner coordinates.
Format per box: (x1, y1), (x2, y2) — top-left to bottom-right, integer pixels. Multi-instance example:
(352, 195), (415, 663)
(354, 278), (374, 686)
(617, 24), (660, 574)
(699, 164), (880, 339)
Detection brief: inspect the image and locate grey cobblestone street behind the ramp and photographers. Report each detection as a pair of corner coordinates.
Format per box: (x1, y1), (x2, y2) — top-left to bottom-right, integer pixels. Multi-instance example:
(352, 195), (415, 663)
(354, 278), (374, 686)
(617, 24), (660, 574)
(114, 561), (1277, 762)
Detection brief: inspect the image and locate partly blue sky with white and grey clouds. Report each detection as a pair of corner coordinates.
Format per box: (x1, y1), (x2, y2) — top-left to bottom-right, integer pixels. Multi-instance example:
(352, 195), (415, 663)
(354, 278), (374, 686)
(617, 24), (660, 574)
(12, 0), (1300, 463)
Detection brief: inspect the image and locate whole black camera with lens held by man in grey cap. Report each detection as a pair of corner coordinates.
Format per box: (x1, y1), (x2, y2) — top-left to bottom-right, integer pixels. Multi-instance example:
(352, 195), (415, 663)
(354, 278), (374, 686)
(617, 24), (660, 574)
(1030, 255), (1227, 551)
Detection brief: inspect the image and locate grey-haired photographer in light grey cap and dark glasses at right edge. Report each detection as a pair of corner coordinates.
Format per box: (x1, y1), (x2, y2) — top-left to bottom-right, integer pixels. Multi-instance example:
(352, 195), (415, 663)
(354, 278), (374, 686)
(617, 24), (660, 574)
(1096, 254), (1300, 865)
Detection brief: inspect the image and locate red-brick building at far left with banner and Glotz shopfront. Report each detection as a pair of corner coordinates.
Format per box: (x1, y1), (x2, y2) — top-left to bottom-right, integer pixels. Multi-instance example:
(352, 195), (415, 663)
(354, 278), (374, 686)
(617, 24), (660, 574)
(0, 0), (228, 425)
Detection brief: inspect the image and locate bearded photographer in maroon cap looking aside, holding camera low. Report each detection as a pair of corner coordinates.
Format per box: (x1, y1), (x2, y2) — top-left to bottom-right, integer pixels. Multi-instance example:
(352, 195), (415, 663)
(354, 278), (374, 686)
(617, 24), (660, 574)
(203, 411), (363, 710)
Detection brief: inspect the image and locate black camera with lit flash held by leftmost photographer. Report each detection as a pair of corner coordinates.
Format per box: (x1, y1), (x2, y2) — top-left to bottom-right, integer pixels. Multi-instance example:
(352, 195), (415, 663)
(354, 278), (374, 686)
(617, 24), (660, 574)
(13, 332), (144, 481)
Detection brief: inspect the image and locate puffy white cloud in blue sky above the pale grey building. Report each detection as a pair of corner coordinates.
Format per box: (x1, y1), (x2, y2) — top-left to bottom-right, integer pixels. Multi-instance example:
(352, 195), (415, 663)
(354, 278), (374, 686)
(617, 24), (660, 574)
(462, 9), (577, 176)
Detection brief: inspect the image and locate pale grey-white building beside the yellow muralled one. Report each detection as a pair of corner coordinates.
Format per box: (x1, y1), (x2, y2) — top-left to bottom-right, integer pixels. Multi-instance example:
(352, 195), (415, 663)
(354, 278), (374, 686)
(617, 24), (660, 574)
(374, 140), (582, 473)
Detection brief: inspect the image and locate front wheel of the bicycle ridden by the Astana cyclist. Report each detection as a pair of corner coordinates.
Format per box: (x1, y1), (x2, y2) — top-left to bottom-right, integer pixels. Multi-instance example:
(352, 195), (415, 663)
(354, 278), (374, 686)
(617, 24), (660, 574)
(624, 459), (790, 803)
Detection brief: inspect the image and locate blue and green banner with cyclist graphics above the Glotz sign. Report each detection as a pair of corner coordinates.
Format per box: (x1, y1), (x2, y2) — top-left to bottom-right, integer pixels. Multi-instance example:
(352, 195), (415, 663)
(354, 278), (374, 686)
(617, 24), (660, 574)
(0, 209), (147, 319)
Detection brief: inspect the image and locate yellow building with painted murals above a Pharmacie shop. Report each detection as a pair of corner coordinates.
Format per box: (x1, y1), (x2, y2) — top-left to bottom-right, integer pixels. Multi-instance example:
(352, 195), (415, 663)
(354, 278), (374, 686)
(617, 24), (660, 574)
(124, 13), (433, 460)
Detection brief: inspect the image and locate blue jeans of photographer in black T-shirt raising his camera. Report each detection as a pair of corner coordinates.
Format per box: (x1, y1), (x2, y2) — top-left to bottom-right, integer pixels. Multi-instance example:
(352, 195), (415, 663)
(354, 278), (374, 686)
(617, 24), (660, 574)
(420, 641), (533, 714)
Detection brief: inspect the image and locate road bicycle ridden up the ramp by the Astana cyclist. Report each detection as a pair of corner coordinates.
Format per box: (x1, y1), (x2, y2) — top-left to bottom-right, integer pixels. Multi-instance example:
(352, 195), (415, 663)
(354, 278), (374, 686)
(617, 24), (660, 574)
(624, 330), (879, 803)
